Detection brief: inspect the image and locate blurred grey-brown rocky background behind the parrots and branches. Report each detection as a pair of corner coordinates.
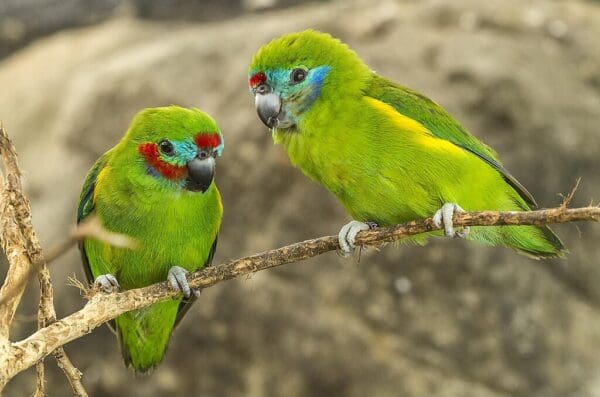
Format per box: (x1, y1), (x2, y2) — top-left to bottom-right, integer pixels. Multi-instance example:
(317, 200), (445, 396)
(0, 0), (600, 397)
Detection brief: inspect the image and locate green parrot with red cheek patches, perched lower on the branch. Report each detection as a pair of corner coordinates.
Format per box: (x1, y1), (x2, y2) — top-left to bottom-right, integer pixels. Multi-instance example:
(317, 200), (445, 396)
(77, 106), (223, 372)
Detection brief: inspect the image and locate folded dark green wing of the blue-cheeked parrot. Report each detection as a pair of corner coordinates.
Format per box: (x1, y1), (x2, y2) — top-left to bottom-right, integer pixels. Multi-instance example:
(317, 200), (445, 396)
(365, 74), (537, 206)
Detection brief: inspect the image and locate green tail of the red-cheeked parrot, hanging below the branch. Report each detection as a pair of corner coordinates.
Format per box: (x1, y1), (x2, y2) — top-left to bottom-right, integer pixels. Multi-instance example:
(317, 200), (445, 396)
(116, 301), (178, 373)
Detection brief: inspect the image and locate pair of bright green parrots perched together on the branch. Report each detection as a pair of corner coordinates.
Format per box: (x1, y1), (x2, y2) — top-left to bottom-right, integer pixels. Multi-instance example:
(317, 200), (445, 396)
(77, 30), (565, 372)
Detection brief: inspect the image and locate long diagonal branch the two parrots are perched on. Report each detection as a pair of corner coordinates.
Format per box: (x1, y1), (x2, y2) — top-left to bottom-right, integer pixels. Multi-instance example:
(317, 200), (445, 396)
(0, 205), (600, 387)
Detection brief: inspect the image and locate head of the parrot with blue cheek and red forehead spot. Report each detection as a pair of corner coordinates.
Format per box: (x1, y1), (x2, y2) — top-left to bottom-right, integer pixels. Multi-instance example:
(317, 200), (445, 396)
(248, 30), (370, 132)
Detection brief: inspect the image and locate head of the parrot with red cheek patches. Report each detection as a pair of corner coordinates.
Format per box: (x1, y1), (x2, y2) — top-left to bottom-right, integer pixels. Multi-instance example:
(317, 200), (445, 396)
(120, 106), (224, 193)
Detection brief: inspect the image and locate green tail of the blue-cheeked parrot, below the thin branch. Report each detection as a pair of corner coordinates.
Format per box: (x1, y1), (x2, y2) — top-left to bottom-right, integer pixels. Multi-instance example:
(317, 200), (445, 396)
(469, 226), (568, 259)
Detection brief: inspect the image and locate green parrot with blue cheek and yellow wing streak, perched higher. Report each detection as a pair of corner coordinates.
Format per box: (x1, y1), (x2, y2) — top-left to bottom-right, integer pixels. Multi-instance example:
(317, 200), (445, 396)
(248, 30), (566, 258)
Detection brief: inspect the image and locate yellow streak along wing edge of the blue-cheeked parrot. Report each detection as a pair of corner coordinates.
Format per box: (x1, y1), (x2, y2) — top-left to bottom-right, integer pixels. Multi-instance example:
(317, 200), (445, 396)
(365, 97), (465, 155)
